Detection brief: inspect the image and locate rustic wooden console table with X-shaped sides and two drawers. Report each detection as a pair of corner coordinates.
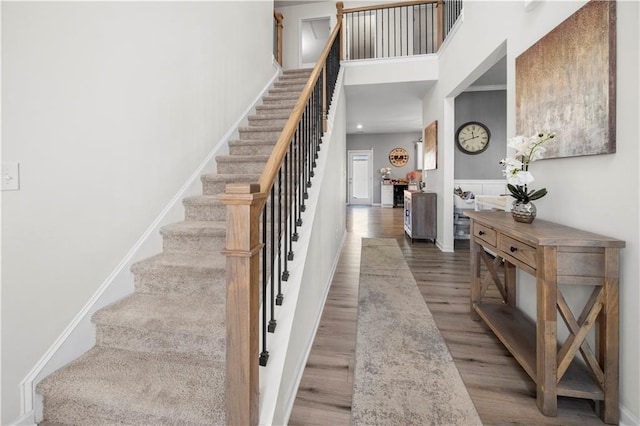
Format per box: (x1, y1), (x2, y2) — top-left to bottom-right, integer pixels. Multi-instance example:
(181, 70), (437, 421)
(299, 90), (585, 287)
(464, 211), (625, 424)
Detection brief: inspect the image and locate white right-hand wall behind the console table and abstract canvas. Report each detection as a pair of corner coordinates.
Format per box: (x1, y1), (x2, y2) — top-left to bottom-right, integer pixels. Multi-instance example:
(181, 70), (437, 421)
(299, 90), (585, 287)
(423, 1), (640, 424)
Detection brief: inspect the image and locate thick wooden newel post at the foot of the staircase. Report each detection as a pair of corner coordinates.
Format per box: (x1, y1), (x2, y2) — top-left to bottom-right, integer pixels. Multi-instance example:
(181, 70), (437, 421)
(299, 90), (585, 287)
(220, 183), (266, 426)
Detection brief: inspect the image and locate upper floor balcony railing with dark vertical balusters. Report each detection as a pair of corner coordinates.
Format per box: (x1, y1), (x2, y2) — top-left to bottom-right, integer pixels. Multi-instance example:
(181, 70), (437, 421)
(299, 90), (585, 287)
(342, 0), (462, 60)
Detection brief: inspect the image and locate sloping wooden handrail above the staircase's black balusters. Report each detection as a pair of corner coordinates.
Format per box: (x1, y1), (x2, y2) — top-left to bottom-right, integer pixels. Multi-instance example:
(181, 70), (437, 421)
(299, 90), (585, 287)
(258, 21), (342, 200)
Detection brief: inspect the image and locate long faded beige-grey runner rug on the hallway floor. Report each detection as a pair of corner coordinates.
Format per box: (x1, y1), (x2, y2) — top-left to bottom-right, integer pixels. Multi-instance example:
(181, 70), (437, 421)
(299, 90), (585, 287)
(351, 238), (482, 426)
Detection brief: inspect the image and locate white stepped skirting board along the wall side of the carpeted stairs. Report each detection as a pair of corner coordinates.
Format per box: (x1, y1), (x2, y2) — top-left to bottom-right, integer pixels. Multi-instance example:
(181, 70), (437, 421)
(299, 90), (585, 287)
(15, 62), (281, 425)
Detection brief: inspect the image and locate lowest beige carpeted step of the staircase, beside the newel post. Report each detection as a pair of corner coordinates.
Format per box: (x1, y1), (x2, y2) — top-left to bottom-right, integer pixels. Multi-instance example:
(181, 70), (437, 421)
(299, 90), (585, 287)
(38, 348), (225, 425)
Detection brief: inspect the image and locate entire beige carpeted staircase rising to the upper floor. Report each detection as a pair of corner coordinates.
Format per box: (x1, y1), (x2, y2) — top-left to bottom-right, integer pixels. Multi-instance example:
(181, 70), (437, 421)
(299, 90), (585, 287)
(37, 70), (310, 425)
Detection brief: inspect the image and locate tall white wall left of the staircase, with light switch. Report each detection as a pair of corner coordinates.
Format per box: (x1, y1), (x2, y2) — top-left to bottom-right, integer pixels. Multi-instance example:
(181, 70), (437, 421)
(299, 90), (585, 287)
(0, 1), (273, 424)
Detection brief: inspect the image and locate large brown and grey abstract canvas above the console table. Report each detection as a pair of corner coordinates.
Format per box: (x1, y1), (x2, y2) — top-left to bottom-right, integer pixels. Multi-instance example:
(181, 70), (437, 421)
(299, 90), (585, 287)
(516, 0), (616, 158)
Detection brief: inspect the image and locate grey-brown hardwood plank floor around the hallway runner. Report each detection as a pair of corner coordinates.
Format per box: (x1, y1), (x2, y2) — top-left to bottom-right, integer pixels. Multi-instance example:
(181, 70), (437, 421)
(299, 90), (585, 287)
(289, 207), (603, 425)
